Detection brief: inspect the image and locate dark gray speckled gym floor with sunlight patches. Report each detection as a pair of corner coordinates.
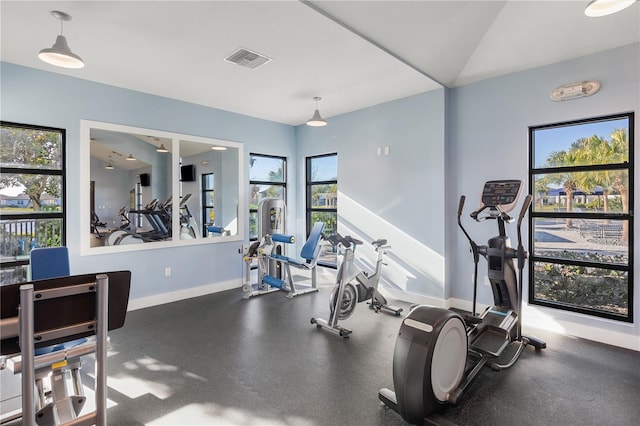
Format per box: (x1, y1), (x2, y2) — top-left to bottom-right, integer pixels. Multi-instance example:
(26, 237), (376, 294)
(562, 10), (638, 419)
(95, 289), (640, 426)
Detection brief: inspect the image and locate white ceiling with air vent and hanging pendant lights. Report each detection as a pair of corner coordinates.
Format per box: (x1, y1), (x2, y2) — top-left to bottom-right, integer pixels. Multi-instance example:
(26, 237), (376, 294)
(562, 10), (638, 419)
(0, 0), (640, 125)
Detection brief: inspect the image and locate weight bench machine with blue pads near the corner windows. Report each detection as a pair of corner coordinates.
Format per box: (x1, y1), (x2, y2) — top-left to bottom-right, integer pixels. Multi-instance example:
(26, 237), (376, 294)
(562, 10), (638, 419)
(242, 222), (324, 299)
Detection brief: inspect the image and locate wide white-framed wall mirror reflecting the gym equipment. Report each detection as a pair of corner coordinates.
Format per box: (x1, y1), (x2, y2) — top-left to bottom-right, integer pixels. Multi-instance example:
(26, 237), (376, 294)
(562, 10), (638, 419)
(81, 120), (244, 254)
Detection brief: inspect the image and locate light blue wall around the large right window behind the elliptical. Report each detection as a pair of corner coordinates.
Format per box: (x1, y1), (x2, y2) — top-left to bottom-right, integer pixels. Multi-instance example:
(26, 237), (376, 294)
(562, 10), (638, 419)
(446, 44), (640, 342)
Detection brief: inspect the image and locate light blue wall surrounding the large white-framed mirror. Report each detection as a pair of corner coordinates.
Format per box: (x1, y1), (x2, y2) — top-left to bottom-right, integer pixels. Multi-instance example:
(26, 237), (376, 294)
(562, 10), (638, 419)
(0, 62), (296, 299)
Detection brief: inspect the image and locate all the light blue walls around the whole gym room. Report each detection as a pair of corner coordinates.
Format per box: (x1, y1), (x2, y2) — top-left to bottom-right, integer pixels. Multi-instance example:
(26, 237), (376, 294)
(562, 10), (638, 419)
(0, 44), (640, 341)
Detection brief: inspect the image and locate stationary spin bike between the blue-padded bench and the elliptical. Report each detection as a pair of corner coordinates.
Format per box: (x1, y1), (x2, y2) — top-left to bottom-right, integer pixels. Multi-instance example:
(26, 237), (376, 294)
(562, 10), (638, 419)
(311, 234), (402, 337)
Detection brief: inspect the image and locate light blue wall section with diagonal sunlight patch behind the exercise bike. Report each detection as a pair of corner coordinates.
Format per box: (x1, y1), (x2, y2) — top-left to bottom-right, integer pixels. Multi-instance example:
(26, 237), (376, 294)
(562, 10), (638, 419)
(296, 89), (445, 300)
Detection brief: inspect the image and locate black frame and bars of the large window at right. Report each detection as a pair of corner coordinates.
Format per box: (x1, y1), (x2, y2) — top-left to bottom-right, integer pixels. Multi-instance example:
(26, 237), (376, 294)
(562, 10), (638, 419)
(528, 112), (634, 323)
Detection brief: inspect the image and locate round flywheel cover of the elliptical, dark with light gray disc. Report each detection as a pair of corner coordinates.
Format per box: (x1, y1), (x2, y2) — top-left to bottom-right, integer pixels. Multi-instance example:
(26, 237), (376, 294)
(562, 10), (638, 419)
(393, 306), (467, 424)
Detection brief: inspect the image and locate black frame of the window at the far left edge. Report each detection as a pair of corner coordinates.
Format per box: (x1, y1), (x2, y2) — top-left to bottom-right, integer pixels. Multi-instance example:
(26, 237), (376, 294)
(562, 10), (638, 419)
(0, 120), (67, 282)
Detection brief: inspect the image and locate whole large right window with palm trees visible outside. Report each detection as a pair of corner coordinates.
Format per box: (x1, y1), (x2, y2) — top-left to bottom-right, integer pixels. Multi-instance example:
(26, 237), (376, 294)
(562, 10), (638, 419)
(529, 113), (634, 322)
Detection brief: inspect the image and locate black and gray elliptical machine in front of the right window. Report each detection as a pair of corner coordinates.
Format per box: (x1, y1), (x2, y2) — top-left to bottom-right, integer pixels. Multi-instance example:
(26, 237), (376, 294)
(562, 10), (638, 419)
(378, 180), (547, 424)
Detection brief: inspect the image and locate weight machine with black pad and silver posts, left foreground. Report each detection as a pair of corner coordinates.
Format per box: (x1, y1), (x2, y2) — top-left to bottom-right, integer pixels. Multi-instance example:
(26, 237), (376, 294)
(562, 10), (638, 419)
(0, 271), (131, 426)
